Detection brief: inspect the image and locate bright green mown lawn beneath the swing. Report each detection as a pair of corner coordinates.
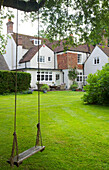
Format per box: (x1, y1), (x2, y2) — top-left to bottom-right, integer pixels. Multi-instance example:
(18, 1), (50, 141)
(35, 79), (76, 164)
(0, 91), (109, 170)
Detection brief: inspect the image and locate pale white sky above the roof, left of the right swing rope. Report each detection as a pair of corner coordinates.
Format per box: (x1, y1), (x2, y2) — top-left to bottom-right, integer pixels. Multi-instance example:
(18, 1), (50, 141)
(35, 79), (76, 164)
(3, 8), (37, 35)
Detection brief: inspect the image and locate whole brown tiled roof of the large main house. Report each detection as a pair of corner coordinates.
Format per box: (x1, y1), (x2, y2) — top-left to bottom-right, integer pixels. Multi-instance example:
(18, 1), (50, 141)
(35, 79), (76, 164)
(12, 33), (94, 63)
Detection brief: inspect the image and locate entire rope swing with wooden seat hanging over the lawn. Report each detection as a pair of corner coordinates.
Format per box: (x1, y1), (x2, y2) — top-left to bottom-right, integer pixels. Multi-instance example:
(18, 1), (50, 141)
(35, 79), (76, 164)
(7, 0), (45, 167)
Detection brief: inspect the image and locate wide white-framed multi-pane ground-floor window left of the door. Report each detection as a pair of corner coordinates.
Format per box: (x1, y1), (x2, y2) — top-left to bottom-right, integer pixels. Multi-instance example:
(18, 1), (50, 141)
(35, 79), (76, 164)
(37, 72), (52, 81)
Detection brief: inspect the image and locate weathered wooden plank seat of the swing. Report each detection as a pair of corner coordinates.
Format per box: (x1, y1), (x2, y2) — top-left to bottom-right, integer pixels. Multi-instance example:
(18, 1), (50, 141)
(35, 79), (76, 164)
(7, 146), (45, 166)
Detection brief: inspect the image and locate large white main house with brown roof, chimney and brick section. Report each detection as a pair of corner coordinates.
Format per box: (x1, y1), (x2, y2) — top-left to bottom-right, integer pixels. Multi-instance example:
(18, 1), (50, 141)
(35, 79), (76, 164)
(4, 21), (101, 88)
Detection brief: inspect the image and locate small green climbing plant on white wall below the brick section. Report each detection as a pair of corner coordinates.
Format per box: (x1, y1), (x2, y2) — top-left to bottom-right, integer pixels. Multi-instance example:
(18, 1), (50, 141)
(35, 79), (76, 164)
(68, 67), (78, 84)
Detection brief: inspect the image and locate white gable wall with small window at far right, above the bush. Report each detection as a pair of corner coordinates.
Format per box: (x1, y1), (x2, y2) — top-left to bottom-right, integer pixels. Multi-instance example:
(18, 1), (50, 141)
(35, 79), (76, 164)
(84, 46), (109, 75)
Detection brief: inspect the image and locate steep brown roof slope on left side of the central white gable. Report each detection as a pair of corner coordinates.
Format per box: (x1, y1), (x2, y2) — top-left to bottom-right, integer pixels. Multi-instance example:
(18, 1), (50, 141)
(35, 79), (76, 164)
(19, 45), (42, 63)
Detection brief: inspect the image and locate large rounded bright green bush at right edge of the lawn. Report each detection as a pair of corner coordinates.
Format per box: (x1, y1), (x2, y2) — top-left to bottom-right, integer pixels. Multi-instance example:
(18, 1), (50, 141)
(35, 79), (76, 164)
(83, 64), (109, 104)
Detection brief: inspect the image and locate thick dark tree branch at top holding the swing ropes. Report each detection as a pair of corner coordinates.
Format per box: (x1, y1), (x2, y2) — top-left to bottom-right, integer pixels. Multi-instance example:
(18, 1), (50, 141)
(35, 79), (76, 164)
(0, 0), (46, 12)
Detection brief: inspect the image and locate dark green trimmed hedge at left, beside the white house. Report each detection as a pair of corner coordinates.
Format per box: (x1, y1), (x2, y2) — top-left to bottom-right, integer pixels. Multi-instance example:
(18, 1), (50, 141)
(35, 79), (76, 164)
(0, 70), (31, 94)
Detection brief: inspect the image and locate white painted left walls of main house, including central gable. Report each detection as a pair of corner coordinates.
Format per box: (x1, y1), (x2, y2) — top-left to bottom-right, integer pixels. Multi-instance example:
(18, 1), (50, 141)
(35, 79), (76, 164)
(4, 34), (63, 88)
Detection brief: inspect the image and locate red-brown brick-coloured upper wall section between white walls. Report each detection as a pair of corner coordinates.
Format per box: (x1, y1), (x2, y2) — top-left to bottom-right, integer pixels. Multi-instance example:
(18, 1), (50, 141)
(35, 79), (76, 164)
(57, 53), (83, 69)
